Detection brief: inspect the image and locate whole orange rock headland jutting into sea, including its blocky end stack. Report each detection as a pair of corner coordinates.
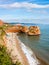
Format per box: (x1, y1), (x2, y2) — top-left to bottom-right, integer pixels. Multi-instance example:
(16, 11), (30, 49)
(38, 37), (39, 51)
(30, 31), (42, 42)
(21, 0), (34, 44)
(4, 25), (40, 35)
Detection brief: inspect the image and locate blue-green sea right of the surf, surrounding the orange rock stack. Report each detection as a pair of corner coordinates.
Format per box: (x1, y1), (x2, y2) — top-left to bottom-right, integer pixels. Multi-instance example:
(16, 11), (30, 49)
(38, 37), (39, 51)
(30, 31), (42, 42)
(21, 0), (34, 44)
(19, 24), (49, 65)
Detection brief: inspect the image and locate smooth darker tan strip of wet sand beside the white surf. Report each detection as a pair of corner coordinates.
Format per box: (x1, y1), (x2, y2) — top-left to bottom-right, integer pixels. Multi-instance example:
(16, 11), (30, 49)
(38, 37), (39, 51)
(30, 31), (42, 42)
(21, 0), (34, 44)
(16, 35), (29, 65)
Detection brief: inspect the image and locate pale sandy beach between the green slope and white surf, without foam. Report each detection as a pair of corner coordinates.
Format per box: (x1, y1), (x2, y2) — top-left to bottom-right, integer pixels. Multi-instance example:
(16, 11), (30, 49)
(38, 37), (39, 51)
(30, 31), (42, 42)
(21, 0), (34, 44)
(4, 31), (29, 65)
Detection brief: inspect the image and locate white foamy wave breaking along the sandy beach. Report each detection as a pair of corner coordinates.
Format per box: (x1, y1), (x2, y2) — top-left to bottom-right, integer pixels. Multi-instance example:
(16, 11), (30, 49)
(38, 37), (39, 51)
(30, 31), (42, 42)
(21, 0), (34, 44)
(20, 41), (40, 65)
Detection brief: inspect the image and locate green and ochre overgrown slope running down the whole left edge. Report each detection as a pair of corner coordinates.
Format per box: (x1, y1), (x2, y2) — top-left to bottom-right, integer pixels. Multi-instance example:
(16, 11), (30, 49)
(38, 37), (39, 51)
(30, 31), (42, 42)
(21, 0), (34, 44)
(0, 24), (22, 65)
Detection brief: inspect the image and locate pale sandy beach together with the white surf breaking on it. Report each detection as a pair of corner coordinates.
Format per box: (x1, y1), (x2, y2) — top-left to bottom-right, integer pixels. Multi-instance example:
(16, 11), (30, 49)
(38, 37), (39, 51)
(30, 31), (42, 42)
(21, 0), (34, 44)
(4, 33), (39, 65)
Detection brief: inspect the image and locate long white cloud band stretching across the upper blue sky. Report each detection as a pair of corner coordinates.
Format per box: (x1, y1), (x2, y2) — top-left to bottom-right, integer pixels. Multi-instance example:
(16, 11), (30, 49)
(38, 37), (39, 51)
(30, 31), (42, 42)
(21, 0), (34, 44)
(0, 2), (49, 9)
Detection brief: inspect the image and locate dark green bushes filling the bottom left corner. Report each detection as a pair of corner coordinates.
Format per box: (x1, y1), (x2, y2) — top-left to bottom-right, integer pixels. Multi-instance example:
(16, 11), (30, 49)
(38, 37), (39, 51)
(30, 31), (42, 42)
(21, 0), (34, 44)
(0, 45), (21, 65)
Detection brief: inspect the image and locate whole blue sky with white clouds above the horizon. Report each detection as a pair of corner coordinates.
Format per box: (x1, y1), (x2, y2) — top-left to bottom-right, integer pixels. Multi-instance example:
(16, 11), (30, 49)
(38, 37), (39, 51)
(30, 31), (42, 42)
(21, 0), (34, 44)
(0, 0), (49, 23)
